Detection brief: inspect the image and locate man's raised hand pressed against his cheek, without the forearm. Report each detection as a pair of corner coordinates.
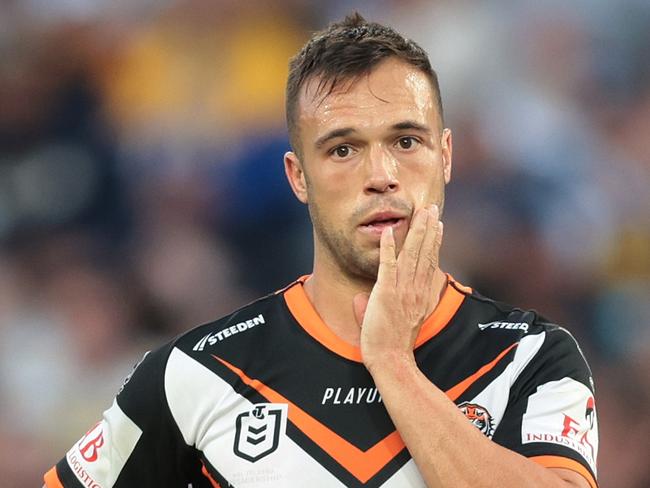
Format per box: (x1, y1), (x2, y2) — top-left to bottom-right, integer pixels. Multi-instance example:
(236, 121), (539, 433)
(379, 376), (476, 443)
(353, 205), (443, 369)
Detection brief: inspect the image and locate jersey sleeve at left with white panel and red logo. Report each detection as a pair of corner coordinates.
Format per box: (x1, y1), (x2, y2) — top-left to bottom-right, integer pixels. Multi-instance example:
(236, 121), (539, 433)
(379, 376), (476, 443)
(44, 346), (210, 488)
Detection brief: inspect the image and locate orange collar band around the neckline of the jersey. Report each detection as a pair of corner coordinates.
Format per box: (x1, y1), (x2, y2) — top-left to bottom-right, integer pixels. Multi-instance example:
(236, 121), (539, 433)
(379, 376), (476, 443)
(284, 275), (468, 362)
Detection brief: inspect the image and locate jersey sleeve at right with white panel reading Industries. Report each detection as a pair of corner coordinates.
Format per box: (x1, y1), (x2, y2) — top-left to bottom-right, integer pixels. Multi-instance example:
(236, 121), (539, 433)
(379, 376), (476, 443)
(493, 326), (598, 488)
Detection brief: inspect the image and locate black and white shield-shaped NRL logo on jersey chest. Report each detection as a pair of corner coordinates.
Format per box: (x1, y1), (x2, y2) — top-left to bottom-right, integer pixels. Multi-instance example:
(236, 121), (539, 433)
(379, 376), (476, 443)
(233, 403), (288, 463)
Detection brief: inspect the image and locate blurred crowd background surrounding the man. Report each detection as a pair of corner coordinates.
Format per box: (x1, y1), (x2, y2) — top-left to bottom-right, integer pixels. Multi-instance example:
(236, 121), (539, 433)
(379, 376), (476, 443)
(0, 0), (650, 488)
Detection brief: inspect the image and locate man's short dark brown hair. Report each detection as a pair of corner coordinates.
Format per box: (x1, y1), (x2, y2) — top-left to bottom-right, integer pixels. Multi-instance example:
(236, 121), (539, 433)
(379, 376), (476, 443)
(286, 12), (443, 150)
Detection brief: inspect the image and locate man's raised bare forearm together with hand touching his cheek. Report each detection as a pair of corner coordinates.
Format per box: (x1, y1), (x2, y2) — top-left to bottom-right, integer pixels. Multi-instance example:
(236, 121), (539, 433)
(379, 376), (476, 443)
(354, 206), (589, 488)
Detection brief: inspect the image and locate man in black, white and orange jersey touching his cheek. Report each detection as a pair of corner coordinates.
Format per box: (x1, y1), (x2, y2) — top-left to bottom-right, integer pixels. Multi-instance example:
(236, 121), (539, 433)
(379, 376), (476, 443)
(45, 15), (598, 488)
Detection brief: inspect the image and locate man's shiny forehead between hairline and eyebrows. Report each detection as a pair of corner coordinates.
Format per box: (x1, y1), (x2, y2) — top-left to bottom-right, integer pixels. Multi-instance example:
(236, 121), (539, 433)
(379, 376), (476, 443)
(298, 58), (437, 139)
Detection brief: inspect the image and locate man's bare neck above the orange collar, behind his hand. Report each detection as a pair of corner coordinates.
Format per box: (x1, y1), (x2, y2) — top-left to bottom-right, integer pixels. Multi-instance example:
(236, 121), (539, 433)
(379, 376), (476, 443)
(304, 248), (447, 346)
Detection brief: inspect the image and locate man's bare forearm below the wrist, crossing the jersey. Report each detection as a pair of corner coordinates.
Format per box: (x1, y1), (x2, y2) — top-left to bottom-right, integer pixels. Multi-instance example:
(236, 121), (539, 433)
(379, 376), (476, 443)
(369, 356), (571, 488)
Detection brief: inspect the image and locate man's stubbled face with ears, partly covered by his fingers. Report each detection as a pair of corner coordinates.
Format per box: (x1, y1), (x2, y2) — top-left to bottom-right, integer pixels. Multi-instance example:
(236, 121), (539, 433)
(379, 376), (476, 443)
(285, 58), (451, 280)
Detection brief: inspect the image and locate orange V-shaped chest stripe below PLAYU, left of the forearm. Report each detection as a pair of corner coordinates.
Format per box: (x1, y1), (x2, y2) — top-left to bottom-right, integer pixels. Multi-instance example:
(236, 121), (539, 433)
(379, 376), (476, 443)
(212, 355), (405, 483)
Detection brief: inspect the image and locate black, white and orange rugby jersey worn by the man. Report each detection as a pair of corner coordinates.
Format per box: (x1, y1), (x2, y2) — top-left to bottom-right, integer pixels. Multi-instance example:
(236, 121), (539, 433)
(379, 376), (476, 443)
(45, 278), (598, 488)
